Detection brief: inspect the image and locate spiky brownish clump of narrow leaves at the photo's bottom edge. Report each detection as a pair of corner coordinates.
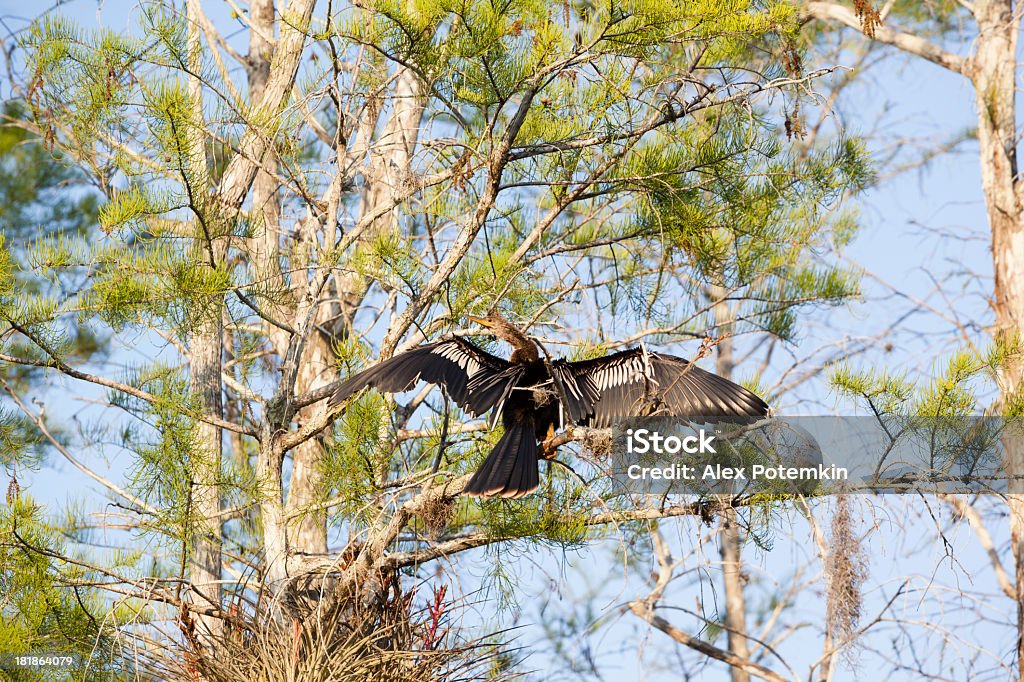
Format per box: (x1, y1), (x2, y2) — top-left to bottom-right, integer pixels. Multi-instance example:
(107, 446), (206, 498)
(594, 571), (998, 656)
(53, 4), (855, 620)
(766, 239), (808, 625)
(145, 573), (517, 682)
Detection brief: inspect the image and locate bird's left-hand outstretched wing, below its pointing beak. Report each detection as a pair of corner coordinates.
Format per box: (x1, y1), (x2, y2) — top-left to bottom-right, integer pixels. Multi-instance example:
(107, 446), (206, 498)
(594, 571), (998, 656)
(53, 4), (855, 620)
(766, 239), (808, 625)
(331, 337), (523, 417)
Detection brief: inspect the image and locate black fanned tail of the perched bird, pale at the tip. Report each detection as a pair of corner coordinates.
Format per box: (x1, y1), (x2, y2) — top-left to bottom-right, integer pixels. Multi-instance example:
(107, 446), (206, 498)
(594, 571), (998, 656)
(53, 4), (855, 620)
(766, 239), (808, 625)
(464, 420), (541, 498)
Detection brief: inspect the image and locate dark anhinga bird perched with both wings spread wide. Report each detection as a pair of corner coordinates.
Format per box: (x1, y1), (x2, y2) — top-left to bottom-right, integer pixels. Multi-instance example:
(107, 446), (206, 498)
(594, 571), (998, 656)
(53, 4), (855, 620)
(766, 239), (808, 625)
(331, 312), (768, 498)
